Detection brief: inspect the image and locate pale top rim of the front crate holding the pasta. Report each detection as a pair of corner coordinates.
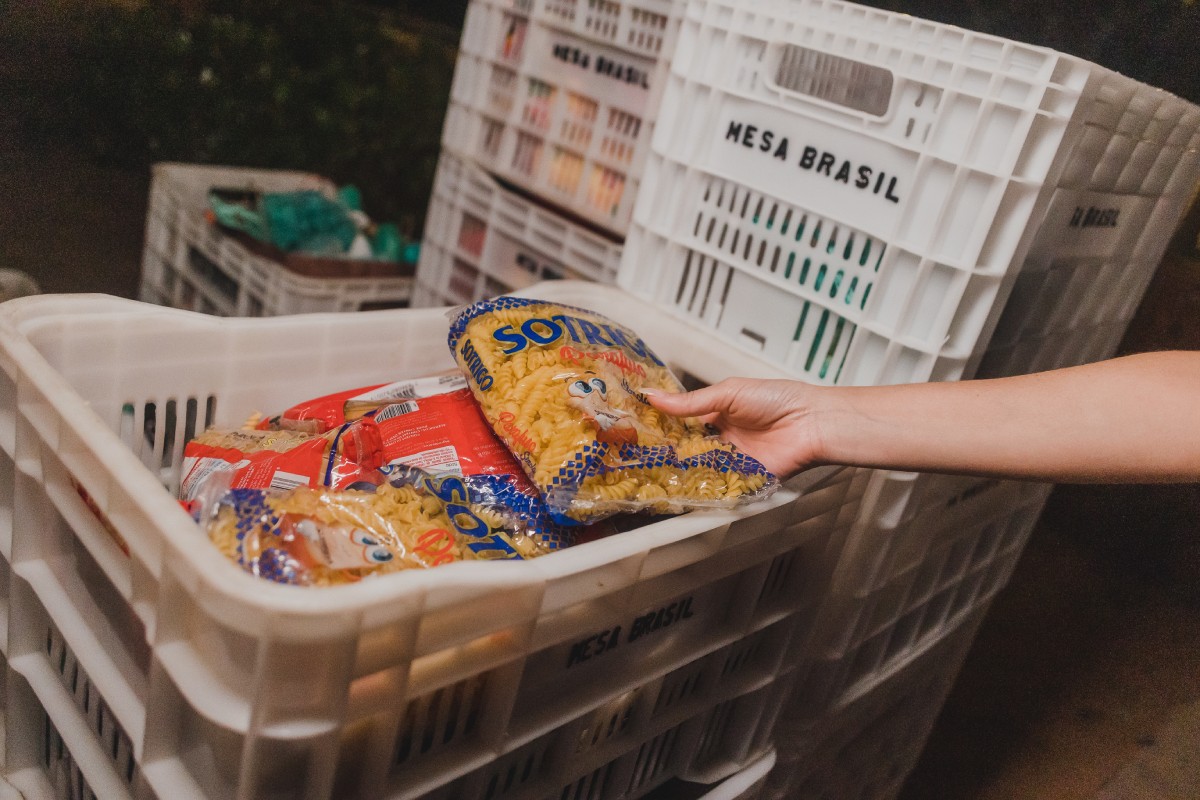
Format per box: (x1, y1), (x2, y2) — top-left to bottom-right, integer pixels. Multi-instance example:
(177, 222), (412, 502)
(0, 294), (841, 631)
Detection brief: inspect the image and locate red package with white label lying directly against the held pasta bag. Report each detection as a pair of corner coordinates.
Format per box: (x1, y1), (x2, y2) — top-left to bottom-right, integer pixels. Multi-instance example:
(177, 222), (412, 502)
(260, 372), (574, 549)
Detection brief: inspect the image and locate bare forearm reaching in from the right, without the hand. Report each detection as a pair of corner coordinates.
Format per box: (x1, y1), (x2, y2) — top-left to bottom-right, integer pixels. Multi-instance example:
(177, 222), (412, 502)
(816, 353), (1200, 482)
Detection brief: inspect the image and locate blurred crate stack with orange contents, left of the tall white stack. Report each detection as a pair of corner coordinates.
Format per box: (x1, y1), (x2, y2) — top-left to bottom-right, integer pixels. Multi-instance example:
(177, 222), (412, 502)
(414, 0), (682, 305)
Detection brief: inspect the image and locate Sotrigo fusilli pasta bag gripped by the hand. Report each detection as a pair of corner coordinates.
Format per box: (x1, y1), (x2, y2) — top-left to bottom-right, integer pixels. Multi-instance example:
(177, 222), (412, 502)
(449, 297), (779, 523)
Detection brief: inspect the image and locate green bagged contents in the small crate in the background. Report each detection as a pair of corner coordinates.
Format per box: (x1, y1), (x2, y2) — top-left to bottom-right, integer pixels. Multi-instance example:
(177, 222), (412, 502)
(206, 186), (420, 277)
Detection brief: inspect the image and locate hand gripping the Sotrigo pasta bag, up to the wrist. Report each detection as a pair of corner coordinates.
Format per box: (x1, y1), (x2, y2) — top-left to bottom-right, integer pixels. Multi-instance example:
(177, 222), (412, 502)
(647, 378), (821, 477)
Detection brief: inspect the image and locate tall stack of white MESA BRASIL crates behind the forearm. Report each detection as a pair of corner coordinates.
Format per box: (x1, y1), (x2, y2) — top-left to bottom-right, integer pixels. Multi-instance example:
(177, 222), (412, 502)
(618, 0), (1200, 798)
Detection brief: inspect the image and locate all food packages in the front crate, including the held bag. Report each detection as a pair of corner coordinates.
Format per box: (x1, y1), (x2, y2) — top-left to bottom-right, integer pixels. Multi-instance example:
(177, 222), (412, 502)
(180, 297), (779, 585)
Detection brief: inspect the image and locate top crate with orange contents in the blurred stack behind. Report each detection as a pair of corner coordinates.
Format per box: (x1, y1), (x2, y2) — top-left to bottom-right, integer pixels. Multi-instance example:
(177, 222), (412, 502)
(442, 0), (683, 235)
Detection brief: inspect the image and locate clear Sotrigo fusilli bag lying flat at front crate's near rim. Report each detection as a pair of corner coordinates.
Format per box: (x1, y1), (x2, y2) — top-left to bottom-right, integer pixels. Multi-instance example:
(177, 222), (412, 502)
(204, 469), (546, 585)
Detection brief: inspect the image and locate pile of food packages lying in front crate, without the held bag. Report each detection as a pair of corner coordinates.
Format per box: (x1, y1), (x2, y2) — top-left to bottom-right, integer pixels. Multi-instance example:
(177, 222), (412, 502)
(180, 373), (580, 585)
